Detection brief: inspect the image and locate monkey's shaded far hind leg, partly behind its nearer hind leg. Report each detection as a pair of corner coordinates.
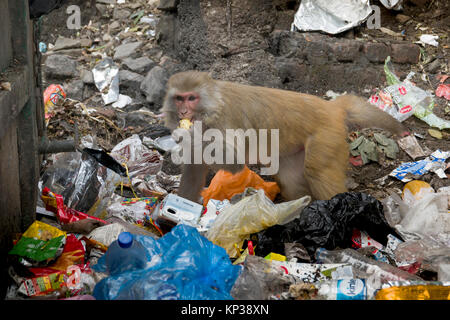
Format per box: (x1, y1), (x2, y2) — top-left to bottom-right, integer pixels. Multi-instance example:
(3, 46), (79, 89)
(275, 150), (311, 201)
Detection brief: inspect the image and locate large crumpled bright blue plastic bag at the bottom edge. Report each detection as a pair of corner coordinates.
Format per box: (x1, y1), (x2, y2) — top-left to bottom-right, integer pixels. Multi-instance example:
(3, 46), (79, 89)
(93, 224), (242, 300)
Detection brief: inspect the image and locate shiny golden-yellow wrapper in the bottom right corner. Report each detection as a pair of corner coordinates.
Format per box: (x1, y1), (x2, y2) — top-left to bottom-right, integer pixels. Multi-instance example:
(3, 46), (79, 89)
(375, 285), (450, 300)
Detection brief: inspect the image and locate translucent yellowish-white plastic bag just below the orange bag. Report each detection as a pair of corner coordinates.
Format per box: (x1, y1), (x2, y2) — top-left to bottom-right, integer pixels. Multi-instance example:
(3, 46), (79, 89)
(206, 189), (311, 258)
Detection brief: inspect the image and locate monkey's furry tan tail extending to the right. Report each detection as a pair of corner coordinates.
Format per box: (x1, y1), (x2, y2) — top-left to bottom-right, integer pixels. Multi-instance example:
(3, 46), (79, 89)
(332, 95), (407, 136)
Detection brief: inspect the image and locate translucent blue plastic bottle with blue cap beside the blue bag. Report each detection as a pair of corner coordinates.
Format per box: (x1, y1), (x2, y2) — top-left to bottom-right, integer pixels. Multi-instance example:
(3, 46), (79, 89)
(105, 232), (148, 275)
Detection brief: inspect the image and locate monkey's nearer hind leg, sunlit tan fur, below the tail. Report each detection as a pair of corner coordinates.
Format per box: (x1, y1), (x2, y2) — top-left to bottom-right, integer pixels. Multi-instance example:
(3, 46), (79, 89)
(305, 131), (349, 200)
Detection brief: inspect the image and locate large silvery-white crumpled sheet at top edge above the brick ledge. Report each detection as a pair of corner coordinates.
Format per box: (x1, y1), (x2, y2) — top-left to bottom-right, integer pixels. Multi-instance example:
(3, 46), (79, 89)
(293, 0), (372, 34)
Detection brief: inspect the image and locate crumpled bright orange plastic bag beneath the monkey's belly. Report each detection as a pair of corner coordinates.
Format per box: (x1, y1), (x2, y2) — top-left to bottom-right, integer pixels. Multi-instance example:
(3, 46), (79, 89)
(201, 166), (280, 207)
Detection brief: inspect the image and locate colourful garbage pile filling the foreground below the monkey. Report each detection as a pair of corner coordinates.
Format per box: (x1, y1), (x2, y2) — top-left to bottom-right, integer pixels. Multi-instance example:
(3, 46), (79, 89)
(6, 135), (450, 300)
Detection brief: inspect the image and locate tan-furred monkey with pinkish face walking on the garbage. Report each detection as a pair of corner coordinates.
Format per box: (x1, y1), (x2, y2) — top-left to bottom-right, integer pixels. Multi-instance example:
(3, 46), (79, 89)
(161, 71), (407, 201)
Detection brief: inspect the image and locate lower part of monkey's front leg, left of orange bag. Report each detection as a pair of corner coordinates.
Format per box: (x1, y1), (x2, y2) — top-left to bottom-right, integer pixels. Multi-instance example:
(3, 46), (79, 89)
(178, 164), (208, 202)
